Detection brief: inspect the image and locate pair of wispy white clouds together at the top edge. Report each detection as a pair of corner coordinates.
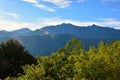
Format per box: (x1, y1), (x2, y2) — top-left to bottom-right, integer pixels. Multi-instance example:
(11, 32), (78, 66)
(22, 0), (72, 12)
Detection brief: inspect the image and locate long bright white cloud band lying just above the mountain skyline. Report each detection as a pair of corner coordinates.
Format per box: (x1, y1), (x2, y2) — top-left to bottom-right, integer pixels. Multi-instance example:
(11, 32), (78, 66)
(0, 17), (120, 31)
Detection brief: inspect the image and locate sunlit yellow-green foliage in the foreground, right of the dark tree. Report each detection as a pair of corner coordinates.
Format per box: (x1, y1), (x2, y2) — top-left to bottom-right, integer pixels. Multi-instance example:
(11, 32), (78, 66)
(1, 38), (120, 80)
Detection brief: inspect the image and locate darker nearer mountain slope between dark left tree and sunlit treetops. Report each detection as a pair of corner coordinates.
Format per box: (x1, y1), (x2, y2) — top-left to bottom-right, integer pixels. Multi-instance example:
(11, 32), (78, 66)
(16, 34), (74, 55)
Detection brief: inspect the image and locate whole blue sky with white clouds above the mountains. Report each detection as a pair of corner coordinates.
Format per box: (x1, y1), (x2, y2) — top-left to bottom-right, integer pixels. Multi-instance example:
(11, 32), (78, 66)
(0, 0), (120, 31)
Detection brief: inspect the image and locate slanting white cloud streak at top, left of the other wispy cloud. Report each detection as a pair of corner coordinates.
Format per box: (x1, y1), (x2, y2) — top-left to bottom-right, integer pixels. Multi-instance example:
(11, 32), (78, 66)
(22, 0), (55, 12)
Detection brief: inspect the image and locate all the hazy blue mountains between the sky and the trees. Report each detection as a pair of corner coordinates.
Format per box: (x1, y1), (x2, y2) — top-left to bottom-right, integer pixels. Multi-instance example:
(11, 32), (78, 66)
(0, 23), (120, 55)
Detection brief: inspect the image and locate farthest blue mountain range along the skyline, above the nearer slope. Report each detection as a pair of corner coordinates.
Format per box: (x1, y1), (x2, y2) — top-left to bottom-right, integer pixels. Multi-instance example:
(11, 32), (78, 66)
(0, 23), (120, 39)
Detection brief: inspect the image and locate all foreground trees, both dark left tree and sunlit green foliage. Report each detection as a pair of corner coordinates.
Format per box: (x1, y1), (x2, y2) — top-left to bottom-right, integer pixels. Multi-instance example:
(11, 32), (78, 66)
(0, 38), (120, 80)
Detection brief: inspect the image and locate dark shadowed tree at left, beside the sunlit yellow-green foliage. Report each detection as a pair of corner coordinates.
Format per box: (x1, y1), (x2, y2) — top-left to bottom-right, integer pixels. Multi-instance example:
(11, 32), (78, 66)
(0, 39), (37, 78)
